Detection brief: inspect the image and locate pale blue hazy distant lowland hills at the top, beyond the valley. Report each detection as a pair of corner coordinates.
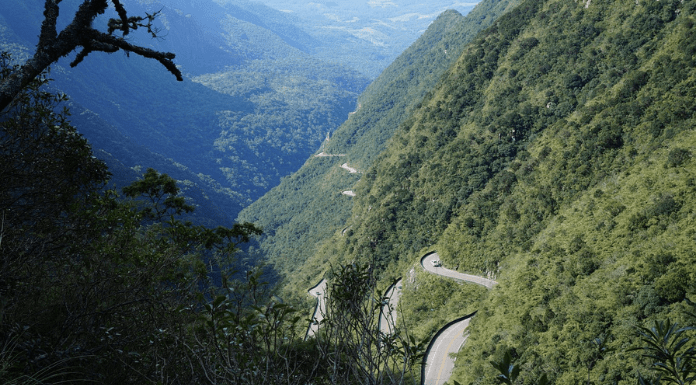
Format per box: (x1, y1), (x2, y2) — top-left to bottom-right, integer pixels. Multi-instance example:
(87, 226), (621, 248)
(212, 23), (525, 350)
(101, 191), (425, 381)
(247, 0), (478, 78)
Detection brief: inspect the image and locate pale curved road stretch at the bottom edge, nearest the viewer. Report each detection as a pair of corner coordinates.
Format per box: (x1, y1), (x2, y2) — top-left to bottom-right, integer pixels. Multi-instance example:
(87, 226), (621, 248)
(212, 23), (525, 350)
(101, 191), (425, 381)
(423, 318), (471, 385)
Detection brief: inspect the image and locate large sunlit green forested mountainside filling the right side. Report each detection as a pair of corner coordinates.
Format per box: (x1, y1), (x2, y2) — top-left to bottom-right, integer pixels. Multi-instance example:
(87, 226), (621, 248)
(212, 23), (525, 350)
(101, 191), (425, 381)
(256, 0), (696, 384)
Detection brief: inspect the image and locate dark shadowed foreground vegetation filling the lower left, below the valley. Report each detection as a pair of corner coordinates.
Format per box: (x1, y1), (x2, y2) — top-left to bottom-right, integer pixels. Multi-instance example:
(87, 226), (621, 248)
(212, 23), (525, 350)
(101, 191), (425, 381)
(0, 54), (432, 385)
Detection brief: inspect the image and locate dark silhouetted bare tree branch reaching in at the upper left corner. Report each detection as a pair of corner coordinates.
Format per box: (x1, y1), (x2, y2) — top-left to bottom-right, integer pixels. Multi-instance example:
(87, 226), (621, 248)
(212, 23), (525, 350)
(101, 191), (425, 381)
(0, 0), (184, 111)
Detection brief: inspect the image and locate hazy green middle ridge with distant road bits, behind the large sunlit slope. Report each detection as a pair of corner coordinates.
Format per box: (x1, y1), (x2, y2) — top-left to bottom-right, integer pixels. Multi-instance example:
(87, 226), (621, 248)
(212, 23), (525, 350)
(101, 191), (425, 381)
(239, 1), (515, 282)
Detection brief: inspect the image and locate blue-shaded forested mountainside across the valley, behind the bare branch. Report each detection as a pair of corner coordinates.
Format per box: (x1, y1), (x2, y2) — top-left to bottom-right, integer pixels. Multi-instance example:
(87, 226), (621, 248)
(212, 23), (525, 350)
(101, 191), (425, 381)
(0, 0), (368, 222)
